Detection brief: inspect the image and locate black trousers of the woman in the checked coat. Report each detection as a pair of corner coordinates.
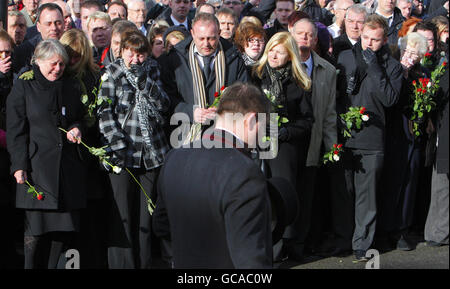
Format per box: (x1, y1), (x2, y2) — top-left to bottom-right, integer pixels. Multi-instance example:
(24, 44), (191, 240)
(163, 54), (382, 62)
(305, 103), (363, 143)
(107, 169), (158, 269)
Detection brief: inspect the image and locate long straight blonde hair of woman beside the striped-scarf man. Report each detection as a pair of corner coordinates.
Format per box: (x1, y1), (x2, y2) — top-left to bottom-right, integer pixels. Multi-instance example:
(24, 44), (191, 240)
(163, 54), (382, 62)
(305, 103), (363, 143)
(253, 31), (311, 90)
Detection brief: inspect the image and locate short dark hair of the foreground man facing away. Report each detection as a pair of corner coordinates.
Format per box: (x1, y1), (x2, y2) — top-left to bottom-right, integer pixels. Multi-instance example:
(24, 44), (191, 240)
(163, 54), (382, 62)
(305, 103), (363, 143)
(217, 82), (272, 119)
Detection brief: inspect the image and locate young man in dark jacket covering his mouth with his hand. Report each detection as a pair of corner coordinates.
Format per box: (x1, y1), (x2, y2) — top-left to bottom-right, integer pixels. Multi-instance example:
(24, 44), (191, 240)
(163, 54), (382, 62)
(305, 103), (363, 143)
(337, 14), (402, 261)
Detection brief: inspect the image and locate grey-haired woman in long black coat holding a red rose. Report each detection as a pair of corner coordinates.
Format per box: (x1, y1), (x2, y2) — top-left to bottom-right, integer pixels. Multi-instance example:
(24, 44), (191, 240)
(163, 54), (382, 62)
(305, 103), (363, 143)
(7, 40), (86, 268)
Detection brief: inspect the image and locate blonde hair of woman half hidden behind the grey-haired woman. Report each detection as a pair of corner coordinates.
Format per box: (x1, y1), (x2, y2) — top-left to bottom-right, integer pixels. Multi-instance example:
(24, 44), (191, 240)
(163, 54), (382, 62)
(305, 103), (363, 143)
(59, 28), (100, 77)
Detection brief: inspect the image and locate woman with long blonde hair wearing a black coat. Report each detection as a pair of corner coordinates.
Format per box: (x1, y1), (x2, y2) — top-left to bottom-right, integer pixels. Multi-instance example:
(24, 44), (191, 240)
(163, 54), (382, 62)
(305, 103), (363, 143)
(253, 32), (314, 187)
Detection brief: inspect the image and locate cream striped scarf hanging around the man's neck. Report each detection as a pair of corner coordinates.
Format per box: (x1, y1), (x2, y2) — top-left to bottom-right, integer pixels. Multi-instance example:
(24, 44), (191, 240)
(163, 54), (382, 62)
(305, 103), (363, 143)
(185, 41), (225, 144)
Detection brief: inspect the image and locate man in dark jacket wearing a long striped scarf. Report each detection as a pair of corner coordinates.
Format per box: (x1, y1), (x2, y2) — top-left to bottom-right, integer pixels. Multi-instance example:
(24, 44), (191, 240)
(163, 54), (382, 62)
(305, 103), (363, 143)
(160, 13), (248, 144)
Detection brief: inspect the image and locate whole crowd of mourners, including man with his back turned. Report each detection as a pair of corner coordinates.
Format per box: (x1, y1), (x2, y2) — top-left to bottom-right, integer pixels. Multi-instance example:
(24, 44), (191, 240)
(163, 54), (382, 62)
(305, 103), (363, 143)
(0, 0), (449, 269)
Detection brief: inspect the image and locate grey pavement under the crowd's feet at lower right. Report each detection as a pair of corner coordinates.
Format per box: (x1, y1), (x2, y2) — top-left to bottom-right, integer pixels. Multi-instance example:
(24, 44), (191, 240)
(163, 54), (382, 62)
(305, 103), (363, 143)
(278, 236), (449, 270)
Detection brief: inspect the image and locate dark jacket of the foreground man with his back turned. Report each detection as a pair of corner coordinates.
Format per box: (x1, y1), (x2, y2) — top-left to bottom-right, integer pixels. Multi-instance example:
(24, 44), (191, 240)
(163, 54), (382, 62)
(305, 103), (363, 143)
(153, 130), (272, 269)
